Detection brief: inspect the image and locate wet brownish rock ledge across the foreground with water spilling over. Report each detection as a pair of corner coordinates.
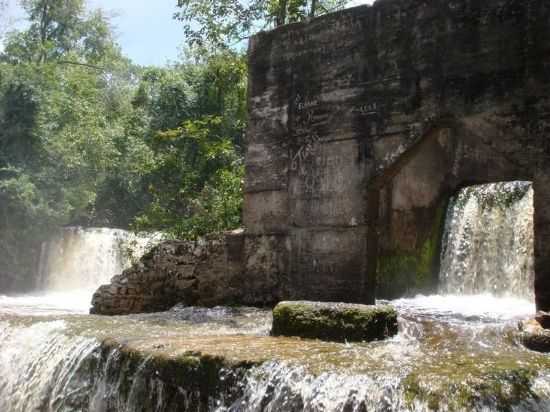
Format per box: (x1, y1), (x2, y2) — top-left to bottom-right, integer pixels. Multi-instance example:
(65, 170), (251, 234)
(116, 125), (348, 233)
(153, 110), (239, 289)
(0, 297), (550, 412)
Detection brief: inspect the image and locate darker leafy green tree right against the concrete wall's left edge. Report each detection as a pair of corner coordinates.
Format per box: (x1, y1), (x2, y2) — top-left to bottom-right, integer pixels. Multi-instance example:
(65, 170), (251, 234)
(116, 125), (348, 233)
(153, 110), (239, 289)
(133, 52), (246, 238)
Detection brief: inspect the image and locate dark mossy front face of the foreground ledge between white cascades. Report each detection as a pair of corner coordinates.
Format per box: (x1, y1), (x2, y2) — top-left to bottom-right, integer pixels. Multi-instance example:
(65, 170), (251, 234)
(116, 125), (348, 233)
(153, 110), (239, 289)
(97, 339), (258, 412)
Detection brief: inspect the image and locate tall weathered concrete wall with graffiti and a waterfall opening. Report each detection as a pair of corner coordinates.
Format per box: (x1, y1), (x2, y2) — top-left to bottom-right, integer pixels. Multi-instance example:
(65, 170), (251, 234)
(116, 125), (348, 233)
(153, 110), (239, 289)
(94, 0), (550, 312)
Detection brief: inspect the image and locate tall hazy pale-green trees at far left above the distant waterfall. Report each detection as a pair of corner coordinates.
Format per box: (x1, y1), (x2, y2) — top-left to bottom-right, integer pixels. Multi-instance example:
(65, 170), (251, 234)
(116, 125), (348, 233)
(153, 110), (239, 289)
(0, 0), (135, 290)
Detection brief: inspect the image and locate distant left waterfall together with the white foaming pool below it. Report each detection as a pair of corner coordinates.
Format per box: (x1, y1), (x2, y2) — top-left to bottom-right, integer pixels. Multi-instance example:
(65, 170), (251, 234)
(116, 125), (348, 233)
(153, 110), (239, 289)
(0, 227), (162, 313)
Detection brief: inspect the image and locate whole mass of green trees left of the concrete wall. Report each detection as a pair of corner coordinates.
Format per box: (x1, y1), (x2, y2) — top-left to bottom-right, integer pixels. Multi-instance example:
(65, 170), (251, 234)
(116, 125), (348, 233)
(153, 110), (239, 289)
(0, 0), (247, 288)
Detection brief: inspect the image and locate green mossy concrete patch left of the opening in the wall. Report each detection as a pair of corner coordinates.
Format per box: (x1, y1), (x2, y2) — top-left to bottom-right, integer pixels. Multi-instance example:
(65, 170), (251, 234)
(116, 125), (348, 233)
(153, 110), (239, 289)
(376, 202), (447, 299)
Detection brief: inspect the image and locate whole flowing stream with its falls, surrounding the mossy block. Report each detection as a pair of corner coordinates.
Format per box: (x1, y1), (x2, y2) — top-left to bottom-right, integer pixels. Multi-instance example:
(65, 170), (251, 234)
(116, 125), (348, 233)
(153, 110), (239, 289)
(0, 187), (550, 412)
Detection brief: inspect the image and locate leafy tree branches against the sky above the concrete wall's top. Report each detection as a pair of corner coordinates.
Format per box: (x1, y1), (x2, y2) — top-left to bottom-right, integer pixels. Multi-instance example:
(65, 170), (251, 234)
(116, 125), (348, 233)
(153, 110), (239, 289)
(175, 0), (349, 48)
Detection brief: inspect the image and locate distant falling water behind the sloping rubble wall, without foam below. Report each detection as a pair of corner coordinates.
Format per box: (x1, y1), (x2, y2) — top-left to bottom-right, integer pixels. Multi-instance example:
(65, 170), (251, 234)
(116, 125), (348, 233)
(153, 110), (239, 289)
(37, 227), (161, 291)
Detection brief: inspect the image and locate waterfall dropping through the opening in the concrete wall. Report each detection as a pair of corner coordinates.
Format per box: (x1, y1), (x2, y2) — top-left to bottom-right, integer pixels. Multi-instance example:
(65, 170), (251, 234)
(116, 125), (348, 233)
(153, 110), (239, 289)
(439, 181), (534, 300)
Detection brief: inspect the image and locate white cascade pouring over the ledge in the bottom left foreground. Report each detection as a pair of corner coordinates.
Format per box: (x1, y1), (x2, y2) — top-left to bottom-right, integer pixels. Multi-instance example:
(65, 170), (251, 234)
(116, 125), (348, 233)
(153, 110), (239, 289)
(0, 320), (202, 412)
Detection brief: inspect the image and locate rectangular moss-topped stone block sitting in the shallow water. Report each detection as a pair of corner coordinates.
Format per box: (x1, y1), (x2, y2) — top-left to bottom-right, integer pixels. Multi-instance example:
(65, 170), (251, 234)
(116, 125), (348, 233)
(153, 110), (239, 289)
(271, 301), (397, 342)
